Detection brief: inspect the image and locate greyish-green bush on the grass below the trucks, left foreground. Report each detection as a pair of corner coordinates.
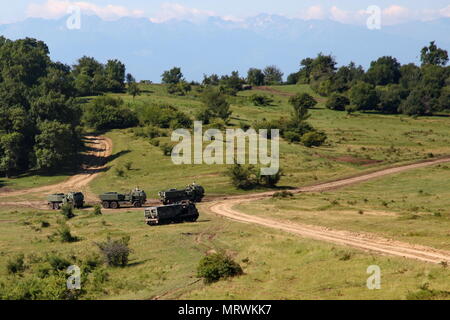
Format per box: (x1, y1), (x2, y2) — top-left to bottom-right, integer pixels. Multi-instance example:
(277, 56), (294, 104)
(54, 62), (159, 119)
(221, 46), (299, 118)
(96, 237), (131, 267)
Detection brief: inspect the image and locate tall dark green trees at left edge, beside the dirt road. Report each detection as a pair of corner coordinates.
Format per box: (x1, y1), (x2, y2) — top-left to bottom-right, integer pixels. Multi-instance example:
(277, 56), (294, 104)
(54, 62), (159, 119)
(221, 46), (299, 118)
(0, 37), (132, 176)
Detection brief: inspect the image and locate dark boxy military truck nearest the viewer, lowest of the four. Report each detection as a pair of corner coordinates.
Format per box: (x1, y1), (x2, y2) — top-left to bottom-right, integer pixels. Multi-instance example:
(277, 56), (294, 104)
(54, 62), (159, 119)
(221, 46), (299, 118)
(144, 201), (199, 226)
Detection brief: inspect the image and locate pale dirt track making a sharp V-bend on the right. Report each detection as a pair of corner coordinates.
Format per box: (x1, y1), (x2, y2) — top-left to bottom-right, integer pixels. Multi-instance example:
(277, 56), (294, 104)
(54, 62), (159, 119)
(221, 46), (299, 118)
(208, 158), (450, 263)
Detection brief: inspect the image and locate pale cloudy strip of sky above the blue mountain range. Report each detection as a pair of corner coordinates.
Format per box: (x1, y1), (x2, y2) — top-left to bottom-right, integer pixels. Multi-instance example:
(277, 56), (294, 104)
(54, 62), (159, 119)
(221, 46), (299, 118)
(0, 0), (450, 24)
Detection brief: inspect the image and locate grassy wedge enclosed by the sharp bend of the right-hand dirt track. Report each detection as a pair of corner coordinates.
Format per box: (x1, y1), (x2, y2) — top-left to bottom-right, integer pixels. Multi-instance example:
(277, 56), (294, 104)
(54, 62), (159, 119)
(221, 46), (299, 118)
(240, 165), (450, 250)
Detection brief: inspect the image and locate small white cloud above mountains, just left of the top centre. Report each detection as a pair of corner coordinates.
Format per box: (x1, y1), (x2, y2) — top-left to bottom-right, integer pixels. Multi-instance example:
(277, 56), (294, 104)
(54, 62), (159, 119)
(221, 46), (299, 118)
(150, 3), (217, 23)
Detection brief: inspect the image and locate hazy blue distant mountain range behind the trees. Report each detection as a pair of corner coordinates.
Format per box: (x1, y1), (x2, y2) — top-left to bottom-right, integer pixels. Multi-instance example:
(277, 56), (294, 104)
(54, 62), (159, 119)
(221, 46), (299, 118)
(0, 14), (450, 82)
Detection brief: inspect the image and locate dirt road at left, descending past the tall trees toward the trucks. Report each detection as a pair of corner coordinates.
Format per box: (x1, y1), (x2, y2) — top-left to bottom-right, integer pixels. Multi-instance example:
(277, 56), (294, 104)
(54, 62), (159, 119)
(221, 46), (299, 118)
(0, 136), (112, 204)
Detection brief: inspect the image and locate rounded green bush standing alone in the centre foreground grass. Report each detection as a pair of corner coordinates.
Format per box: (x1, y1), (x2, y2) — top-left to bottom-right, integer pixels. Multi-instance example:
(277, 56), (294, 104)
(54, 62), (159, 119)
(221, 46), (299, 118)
(197, 253), (243, 283)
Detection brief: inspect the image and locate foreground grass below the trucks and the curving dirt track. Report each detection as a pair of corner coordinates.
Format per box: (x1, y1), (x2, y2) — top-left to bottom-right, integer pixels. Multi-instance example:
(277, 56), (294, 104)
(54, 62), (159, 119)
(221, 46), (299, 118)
(0, 205), (450, 299)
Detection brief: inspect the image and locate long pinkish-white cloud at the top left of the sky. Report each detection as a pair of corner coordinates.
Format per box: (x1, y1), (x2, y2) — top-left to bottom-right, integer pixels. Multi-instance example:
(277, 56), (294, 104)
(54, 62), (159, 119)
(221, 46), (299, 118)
(27, 0), (144, 20)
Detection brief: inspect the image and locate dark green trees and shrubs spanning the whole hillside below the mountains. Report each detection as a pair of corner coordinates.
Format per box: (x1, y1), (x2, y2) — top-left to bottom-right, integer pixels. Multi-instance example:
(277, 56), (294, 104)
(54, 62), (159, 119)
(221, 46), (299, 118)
(0, 37), (450, 176)
